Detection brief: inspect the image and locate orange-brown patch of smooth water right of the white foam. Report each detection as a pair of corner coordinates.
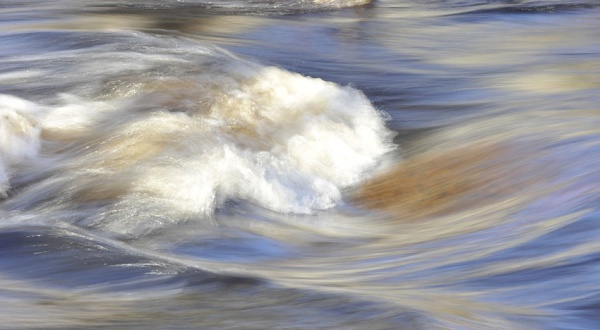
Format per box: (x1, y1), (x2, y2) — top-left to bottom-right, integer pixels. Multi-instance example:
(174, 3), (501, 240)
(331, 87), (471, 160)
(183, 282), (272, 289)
(355, 142), (544, 217)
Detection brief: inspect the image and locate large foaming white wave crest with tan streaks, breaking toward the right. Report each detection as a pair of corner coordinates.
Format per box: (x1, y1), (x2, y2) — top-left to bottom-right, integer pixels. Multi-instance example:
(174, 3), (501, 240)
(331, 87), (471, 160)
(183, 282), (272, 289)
(0, 34), (392, 235)
